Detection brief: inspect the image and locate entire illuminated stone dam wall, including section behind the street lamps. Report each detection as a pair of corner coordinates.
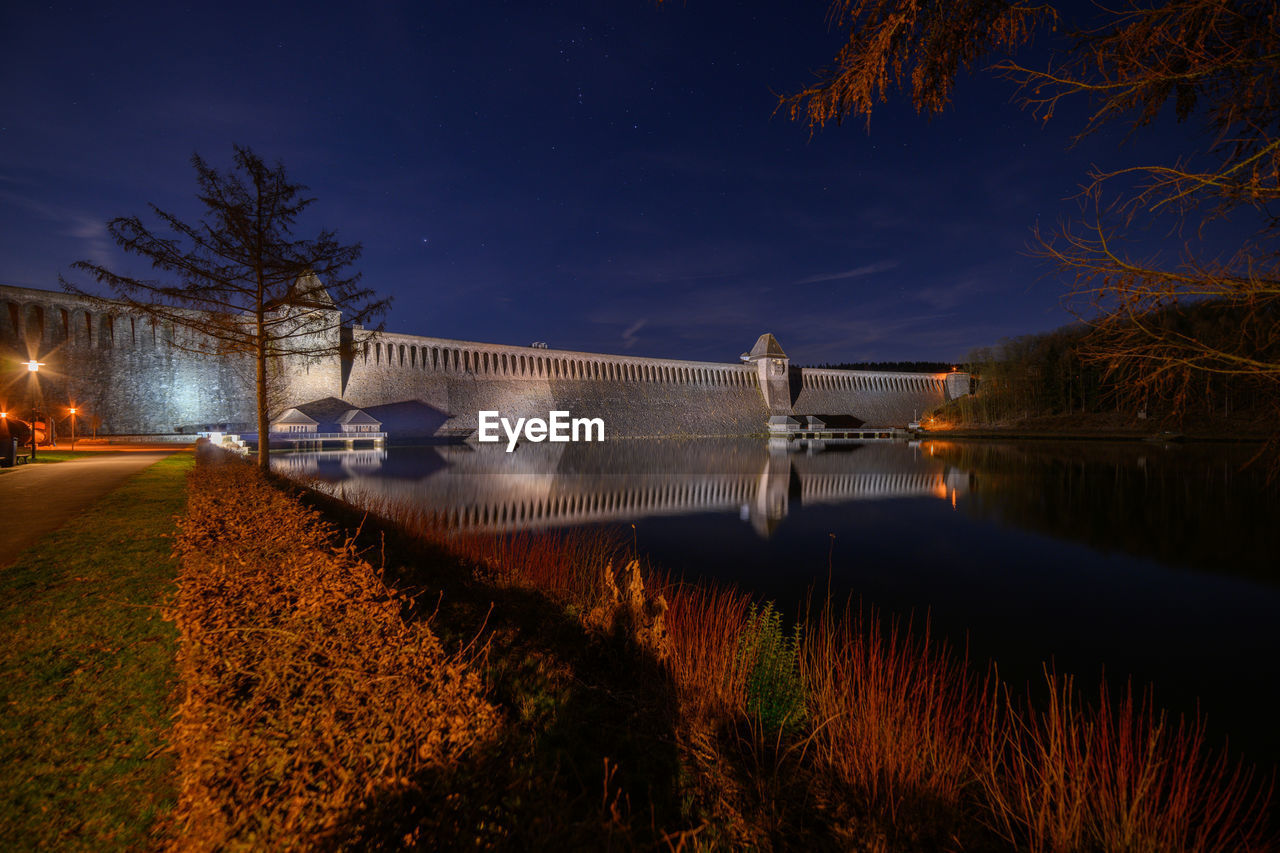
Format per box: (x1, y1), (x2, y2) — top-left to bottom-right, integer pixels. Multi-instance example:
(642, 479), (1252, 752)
(0, 286), (968, 439)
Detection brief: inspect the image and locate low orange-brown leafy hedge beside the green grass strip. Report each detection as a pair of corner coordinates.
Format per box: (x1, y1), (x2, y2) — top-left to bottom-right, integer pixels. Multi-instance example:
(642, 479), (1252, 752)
(173, 455), (497, 849)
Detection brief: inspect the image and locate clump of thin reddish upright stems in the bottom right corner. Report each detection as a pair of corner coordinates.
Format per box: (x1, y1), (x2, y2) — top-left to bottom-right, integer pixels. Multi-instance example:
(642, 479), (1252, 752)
(979, 672), (1275, 853)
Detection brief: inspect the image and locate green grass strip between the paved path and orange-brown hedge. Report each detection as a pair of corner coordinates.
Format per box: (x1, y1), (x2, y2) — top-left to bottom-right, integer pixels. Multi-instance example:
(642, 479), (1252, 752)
(0, 453), (195, 849)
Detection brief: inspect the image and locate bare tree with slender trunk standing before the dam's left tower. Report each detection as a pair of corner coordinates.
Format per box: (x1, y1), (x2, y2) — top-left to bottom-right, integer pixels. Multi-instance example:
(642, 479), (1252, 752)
(60, 146), (389, 467)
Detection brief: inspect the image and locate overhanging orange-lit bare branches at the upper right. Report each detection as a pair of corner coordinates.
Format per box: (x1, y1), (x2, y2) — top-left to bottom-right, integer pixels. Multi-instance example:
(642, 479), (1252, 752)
(780, 0), (1280, 422)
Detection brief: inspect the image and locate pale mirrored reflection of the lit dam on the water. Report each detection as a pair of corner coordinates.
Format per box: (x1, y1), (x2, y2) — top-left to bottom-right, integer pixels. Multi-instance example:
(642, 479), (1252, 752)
(273, 439), (968, 535)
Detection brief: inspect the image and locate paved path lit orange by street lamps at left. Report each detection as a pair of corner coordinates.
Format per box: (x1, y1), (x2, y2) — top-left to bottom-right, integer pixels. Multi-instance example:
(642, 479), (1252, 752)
(0, 452), (176, 569)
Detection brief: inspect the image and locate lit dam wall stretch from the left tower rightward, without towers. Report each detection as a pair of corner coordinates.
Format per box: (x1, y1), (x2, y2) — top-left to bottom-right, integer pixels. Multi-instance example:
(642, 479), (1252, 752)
(343, 329), (968, 437)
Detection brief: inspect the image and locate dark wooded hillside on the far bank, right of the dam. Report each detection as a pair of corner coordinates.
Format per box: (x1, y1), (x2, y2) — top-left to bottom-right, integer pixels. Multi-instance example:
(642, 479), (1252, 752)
(945, 302), (1280, 424)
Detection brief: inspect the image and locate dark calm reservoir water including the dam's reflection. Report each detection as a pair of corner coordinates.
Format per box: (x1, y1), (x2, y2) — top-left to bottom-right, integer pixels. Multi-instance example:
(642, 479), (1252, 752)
(273, 439), (1280, 767)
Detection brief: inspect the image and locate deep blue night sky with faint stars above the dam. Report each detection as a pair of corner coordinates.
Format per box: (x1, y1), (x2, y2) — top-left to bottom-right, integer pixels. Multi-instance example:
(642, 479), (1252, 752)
(0, 0), (1198, 364)
